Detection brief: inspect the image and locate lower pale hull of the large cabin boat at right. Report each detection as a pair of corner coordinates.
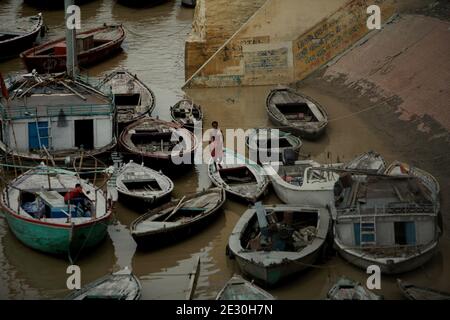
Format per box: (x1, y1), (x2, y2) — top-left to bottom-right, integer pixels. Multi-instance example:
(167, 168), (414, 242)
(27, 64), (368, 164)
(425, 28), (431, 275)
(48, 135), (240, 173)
(334, 240), (437, 274)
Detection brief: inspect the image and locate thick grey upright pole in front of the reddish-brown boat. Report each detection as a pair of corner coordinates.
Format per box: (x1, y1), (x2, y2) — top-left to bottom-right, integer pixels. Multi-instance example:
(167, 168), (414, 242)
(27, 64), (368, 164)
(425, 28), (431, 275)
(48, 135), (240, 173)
(64, 0), (78, 79)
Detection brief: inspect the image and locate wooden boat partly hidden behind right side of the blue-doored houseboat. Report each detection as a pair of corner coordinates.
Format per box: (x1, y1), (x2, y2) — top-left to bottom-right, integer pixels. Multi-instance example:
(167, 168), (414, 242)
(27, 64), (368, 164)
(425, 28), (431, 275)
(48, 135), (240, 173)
(99, 70), (155, 130)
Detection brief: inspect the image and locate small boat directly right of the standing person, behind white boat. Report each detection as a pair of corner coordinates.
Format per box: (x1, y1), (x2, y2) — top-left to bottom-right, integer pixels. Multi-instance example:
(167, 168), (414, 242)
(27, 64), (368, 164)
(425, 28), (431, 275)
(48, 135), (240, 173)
(246, 129), (303, 163)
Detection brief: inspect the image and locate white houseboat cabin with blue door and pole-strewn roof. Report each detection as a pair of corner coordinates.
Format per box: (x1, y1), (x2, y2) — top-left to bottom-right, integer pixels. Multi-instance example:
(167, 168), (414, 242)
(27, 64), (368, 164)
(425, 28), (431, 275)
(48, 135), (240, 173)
(0, 74), (115, 160)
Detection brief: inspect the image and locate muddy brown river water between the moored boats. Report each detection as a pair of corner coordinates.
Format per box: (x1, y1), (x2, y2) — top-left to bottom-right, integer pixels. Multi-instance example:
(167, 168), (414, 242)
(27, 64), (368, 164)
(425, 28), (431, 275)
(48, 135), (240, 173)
(0, 0), (450, 299)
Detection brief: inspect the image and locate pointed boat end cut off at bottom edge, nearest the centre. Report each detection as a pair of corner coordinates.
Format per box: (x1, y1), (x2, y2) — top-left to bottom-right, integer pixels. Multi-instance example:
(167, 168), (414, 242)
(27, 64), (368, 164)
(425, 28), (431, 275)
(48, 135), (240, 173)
(216, 274), (275, 300)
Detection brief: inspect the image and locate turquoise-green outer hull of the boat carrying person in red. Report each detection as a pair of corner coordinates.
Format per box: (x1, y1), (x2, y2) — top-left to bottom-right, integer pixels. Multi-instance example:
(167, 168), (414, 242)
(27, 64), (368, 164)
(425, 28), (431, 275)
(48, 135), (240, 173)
(3, 211), (109, 256)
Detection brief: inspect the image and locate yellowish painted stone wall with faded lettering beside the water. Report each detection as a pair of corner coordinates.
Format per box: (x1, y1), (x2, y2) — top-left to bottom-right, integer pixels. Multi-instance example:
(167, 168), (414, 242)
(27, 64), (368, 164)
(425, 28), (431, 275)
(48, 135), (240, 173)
(185, 0), (394, 87)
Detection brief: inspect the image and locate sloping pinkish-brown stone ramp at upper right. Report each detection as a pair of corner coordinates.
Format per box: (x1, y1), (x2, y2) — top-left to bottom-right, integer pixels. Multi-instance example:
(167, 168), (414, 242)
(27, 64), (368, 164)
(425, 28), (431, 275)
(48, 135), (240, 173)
(323, 15), (450, 131)
